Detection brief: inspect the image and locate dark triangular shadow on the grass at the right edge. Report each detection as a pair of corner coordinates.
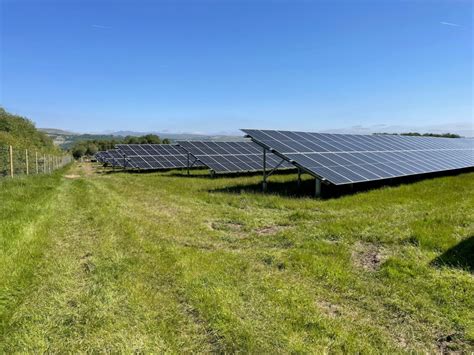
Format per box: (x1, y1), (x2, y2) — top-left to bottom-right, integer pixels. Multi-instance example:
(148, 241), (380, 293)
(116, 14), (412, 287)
(431, 235), (474, 273)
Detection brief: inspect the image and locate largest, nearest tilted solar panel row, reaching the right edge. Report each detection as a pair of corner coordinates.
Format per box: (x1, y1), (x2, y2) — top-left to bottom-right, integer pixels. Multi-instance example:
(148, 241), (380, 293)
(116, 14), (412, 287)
(242, 129), (474, 185)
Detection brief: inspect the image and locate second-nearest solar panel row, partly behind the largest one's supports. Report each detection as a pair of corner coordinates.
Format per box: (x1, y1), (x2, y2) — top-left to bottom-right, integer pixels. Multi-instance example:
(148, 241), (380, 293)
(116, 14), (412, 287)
(178, 141), (294, 173)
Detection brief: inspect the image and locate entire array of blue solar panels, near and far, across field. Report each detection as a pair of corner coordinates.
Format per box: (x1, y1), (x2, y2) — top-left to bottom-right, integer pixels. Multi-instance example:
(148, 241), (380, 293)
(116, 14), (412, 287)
(97, 129), (474, 185)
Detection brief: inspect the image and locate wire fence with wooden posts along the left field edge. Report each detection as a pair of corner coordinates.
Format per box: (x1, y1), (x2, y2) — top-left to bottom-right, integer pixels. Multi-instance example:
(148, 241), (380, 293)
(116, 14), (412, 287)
(0, 145), (72, 178)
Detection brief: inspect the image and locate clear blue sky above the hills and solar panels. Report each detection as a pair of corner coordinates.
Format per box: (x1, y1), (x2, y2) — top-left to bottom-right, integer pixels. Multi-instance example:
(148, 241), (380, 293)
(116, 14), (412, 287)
(0, 0), (473, 133)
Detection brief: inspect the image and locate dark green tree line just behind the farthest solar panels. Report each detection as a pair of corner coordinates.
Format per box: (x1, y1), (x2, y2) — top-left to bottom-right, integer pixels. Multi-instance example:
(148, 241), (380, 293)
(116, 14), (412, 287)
(71, 134), (171, 159)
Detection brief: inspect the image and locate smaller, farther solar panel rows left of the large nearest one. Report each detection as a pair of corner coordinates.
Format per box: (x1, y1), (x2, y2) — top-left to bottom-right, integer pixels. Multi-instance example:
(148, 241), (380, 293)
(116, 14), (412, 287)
(96, 141), (294, 173)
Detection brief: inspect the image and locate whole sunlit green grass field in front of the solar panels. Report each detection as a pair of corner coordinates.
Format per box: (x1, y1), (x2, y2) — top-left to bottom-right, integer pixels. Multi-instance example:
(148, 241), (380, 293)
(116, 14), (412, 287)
(0, 164), (474, 353)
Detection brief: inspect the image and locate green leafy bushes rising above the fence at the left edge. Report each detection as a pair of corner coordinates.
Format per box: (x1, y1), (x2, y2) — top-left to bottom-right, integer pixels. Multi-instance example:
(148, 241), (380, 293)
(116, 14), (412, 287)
(0, 107), (57, 152)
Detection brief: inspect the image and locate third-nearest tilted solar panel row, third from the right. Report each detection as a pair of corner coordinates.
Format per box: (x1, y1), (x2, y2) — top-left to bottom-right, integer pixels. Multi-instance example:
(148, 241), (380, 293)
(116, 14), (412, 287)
(116, 144), (203, 170)
